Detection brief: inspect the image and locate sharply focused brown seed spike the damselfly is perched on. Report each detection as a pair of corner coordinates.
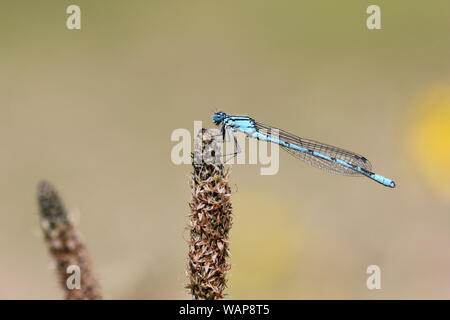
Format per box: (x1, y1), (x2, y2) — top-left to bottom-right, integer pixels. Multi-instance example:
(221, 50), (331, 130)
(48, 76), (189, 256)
(186, 129), (232, 300)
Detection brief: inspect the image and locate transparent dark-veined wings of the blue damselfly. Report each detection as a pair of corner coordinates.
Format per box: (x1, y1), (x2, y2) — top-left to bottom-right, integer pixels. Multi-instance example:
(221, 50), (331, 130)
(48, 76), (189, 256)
(255, 123), (372, 176)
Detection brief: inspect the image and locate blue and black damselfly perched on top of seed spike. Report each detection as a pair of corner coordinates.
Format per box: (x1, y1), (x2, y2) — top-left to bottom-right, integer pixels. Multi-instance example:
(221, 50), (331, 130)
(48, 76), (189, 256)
(212, 112), (395, 188)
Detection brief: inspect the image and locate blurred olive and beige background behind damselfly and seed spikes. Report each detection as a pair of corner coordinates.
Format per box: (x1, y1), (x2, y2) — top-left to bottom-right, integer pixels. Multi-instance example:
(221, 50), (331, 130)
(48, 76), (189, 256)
(0, 0), (450, 299)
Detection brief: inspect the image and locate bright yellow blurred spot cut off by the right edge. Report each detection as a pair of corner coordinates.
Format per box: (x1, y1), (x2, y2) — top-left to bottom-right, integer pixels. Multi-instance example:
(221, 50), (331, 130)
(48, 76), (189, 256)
(410, 86), (450, 197)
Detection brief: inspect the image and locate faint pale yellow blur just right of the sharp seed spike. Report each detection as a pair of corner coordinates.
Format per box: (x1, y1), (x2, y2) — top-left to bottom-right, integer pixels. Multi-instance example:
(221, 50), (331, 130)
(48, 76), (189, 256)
(228, 194), (303, 299)
